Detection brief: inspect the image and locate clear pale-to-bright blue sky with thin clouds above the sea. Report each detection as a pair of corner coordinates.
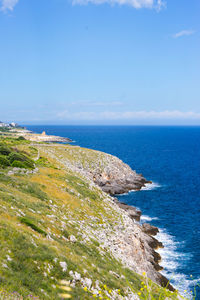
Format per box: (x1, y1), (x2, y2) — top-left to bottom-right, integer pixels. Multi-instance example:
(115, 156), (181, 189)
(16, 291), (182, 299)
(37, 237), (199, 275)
(0, 0), (200, 125)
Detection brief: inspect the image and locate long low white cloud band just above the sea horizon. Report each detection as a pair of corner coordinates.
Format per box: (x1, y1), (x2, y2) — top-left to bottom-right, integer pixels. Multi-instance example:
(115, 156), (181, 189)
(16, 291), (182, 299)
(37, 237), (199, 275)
(57, 110), (200, 121)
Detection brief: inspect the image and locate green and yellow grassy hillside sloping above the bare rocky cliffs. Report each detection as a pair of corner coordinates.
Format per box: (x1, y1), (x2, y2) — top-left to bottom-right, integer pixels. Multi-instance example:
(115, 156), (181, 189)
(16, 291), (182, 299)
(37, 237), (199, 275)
(0, 137), (184, 299)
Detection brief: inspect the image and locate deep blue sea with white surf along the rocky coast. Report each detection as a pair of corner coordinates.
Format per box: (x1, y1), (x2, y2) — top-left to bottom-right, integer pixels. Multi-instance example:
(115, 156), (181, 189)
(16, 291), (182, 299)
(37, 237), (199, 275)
(27, 126), (200, 299)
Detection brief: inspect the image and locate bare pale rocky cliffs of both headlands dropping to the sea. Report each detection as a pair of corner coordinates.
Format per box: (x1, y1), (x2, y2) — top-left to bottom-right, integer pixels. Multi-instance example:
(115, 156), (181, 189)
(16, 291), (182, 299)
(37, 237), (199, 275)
(40, 145), (175, 291)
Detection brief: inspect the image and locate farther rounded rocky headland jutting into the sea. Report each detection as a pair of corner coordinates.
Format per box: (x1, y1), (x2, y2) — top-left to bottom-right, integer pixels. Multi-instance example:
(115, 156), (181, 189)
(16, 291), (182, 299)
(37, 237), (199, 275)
(41, 147), (150, 195)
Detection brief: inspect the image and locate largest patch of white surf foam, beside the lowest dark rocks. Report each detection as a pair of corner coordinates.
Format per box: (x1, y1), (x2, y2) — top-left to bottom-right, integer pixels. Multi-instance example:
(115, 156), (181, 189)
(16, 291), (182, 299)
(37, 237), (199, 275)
(156, 228), (198, 299)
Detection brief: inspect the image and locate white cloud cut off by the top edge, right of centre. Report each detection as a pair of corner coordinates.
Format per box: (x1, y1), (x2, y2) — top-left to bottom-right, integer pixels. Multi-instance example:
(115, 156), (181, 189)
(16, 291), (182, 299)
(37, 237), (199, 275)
(72, 0), (165, 10)
